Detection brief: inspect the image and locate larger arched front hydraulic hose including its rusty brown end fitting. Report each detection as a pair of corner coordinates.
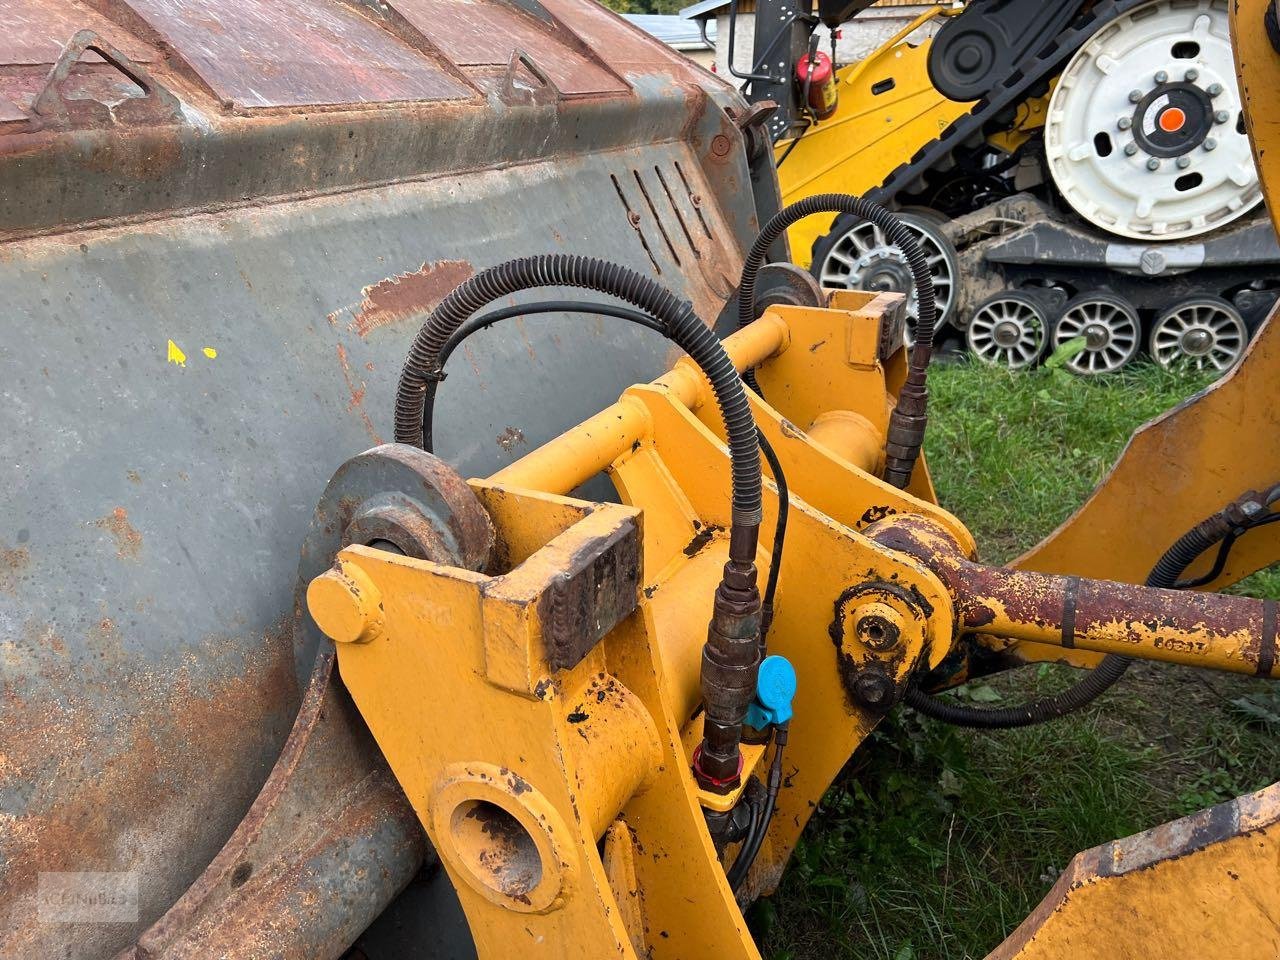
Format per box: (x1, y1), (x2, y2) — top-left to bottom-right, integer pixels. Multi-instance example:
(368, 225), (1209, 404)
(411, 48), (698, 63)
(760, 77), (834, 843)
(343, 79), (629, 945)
(396, 253), (763, 792)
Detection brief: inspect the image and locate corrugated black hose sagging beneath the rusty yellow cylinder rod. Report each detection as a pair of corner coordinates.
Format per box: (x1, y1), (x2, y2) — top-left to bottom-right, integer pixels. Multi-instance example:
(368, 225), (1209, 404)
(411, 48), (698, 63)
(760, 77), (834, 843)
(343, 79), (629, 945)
(904, 513), (1230, 730)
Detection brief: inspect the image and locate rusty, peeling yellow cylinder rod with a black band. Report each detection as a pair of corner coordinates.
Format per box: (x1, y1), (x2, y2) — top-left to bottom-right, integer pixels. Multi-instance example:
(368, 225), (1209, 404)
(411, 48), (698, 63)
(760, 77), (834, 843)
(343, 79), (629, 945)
(872, 517), (1280, 678)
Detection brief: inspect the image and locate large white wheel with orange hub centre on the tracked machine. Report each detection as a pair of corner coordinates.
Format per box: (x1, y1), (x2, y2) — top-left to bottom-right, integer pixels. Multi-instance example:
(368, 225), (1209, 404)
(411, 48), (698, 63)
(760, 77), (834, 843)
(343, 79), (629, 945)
(1044, 0), (1262, 239)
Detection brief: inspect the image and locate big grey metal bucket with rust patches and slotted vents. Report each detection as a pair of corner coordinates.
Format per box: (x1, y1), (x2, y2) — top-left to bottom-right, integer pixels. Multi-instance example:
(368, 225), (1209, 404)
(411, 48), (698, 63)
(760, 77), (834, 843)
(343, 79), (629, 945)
(0, 0), (776, 959)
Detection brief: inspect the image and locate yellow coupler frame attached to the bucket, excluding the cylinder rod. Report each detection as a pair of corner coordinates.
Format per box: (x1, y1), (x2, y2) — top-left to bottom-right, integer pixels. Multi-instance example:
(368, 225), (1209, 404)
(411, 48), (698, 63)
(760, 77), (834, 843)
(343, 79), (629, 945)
(307, 235), (1276, 960)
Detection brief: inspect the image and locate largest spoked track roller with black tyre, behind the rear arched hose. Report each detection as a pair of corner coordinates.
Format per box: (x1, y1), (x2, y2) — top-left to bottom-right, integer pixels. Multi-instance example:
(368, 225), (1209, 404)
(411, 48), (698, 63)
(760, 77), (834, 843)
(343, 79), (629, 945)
(813, 210), (960, 343)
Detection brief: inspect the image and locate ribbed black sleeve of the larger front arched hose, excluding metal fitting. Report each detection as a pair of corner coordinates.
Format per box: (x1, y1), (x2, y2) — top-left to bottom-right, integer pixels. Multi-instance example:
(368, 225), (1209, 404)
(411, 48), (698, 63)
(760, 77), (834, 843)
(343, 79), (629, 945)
(396, 253), (762, 529)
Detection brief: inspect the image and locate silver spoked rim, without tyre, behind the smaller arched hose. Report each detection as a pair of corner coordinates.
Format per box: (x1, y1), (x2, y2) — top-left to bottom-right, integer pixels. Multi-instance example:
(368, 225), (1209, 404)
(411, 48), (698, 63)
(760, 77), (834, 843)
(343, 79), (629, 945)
(818, 218), (956, 343)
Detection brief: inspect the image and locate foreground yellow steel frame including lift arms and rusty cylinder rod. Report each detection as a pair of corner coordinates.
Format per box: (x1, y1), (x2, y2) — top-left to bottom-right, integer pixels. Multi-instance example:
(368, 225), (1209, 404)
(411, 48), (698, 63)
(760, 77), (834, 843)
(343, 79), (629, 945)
(296, 0), (1280, 960)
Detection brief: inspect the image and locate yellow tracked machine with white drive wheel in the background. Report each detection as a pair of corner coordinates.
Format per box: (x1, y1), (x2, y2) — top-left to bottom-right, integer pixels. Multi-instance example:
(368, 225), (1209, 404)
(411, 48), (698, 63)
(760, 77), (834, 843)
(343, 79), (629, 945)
(711, 0), (1280, 375)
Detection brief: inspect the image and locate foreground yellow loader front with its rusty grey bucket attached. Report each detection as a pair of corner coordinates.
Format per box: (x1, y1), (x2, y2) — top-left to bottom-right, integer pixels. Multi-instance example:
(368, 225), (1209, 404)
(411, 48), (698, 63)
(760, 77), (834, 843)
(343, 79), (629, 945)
(0, 0), (1280, 960)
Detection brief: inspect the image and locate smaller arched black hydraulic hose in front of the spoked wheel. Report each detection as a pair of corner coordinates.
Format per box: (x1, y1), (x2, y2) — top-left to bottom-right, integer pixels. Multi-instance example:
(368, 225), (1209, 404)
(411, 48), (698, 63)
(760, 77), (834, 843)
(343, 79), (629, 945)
(737, 193), (937, 489)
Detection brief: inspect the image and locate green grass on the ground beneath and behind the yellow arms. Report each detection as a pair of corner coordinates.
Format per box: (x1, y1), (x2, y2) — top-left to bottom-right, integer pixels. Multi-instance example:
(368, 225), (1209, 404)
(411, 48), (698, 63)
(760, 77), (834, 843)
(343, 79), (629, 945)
(750, 364), (1280, 960)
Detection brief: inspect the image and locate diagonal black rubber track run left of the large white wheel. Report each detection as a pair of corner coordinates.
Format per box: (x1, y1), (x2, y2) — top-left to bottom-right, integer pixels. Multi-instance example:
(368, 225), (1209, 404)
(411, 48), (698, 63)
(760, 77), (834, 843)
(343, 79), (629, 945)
(865, 0), (1149, 208)
